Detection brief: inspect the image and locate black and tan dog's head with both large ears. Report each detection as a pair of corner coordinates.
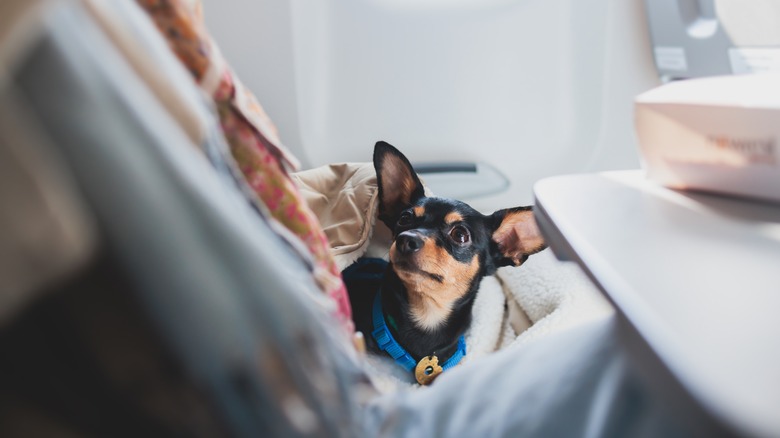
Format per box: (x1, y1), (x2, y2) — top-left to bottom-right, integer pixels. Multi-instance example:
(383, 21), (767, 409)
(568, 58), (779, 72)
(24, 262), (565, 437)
(374, 141), (545, 329)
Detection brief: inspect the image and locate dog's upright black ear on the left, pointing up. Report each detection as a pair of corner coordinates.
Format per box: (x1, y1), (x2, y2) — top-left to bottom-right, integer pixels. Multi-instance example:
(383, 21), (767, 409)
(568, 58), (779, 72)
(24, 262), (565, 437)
(374, 141), (425, 230)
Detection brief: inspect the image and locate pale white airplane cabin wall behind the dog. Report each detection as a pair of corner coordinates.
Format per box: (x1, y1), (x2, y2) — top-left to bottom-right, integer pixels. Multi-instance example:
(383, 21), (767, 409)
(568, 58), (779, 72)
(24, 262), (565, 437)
(204, 0), (659, 211)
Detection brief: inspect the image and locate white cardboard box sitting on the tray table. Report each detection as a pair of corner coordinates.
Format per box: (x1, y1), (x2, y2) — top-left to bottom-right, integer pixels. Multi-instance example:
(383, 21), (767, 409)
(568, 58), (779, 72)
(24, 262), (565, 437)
(635, 73), (780, 201)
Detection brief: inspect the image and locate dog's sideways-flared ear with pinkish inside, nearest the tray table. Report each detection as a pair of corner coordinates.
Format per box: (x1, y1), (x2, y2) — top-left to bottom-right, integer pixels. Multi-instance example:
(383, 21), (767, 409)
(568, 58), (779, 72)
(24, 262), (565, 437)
(490, 207), (547, 266)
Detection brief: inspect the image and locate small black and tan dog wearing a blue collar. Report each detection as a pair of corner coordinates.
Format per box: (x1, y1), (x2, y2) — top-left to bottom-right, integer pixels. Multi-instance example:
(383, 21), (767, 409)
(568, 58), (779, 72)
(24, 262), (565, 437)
(345, 142), (545, 384)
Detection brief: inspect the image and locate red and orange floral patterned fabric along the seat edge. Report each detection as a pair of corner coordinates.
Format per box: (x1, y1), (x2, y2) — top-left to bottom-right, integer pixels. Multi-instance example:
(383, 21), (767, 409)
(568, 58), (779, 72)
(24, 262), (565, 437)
(137, 0), (354, 332)
